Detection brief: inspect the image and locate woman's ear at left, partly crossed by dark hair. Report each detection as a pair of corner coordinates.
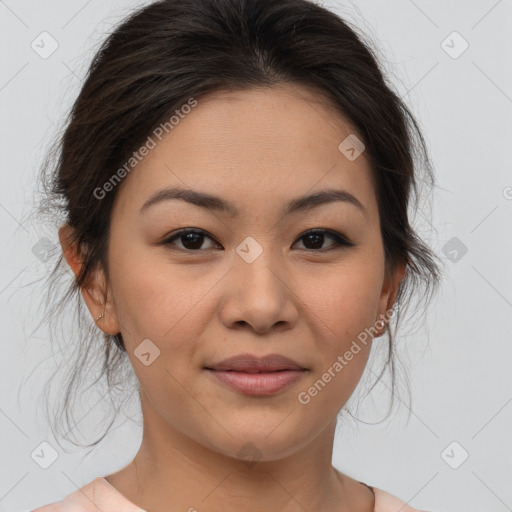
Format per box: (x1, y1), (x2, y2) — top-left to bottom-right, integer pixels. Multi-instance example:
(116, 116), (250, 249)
(59, 224), (121, 335)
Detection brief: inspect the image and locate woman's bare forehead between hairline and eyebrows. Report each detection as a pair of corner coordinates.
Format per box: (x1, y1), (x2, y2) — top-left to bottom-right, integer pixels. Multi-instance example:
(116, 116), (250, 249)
(113, 85), (376, 221)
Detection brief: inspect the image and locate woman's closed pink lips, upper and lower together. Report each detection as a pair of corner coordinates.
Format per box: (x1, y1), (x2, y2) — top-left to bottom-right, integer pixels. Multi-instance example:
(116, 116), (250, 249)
(205, 354), (307, 396)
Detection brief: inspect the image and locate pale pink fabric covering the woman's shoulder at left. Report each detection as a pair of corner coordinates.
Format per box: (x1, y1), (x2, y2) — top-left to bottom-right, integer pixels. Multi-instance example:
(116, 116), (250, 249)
(31, 477), (146, 512)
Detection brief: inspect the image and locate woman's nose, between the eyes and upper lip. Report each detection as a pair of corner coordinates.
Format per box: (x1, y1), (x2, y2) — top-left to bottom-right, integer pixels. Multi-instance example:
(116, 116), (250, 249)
(220, 245), (299, 334)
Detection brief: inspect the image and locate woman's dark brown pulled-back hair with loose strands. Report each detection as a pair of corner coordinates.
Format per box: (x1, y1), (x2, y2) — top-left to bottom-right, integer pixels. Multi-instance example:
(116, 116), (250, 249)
(35, 0), (440, 446)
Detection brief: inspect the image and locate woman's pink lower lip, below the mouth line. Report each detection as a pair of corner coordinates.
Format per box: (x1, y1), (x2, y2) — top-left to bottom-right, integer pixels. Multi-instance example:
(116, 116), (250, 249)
(208, 370), (305, 396)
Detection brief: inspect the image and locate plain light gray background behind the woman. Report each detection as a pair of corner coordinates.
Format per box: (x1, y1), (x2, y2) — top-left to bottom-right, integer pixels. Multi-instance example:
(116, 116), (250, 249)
(0, 0), (512, 512)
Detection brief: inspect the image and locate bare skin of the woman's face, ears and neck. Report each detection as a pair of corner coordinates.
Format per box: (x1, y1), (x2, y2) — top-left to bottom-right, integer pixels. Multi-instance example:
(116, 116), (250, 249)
(59, 85), (404, 512)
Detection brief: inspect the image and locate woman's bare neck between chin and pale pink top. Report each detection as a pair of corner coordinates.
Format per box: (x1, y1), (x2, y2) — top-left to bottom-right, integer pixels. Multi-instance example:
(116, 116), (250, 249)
(107, 394), (373, 512)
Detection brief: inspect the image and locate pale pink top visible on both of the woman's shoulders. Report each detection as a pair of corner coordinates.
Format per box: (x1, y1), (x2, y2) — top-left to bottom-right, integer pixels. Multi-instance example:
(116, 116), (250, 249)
(32, 477), (428, 512)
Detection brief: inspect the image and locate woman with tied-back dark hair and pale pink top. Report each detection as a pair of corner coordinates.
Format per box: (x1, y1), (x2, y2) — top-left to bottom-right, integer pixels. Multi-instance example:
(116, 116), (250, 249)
(31, 0), (439, 512)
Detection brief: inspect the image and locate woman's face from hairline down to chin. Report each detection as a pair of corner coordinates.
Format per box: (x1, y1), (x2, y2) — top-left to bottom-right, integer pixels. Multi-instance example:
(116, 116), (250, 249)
(72, 86), (401, 460)
